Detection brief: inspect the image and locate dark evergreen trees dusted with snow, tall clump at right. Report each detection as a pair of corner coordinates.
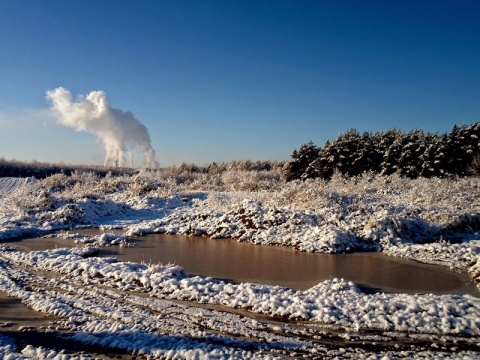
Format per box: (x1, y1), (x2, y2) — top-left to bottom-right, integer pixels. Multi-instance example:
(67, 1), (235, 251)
(283, 123), (480, 181)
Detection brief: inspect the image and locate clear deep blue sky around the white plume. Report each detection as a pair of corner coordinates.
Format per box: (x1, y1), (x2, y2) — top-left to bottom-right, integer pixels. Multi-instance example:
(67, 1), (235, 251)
(0, 0), (480, 166)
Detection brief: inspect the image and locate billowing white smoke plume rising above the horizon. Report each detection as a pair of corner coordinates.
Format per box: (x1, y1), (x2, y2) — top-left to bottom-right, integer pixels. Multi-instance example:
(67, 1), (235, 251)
(46, 87), (158, 168)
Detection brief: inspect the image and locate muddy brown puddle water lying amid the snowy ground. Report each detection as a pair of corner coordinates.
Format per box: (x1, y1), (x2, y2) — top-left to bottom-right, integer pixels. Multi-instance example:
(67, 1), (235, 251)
(4, 229), (480, 296)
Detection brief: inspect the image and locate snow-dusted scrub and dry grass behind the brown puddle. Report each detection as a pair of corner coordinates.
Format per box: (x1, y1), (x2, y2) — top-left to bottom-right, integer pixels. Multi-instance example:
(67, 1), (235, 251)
(0, 165), (480, 258)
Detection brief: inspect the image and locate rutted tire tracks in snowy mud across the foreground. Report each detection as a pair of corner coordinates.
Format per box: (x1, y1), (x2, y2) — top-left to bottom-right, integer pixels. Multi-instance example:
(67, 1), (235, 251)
(3, 256), (480, 358)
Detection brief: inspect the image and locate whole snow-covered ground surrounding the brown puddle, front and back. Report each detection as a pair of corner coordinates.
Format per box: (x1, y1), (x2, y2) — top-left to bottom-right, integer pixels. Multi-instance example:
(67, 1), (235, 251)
(0, 171), (480, 359)
